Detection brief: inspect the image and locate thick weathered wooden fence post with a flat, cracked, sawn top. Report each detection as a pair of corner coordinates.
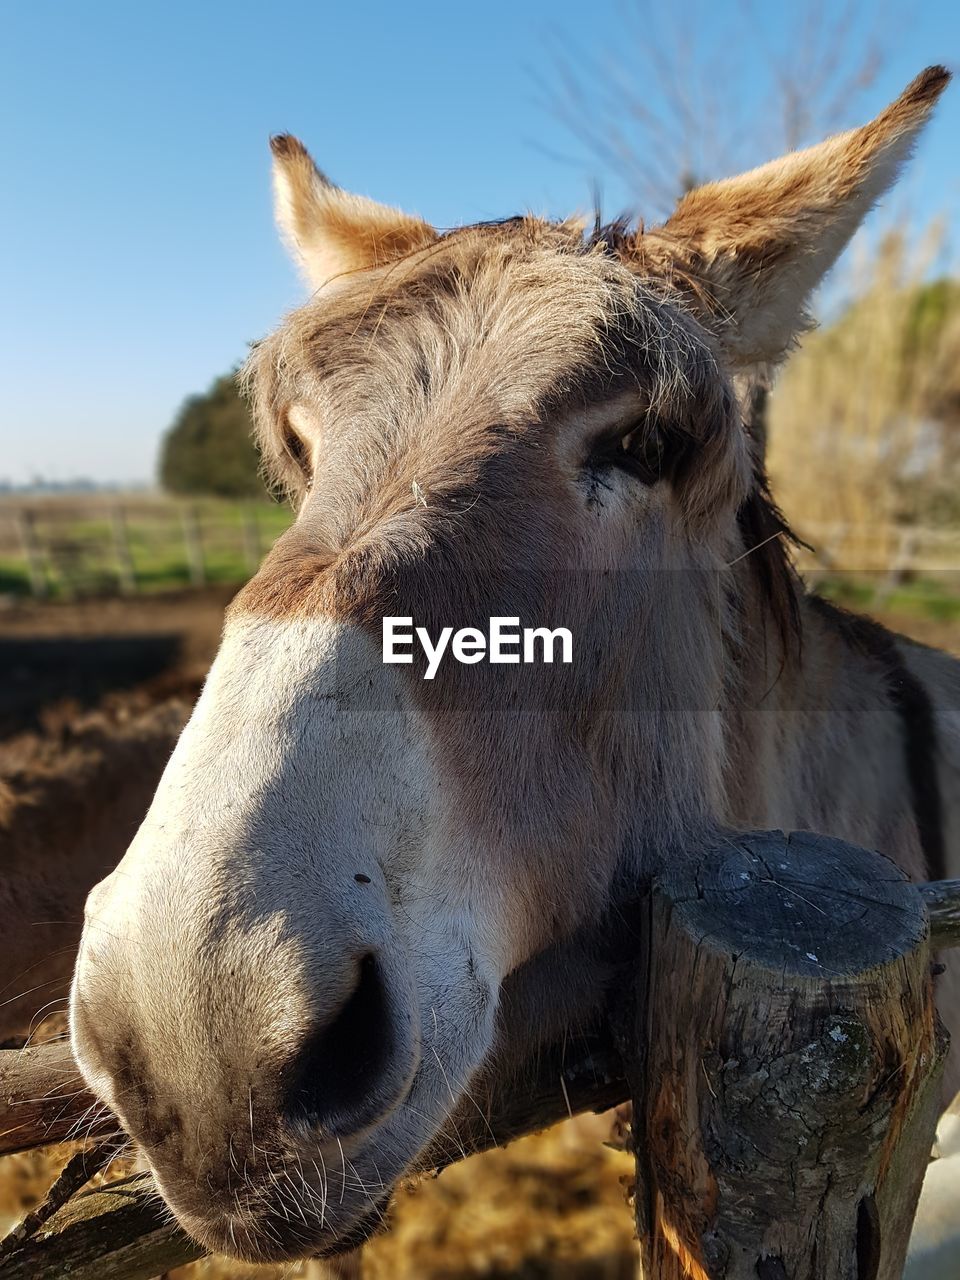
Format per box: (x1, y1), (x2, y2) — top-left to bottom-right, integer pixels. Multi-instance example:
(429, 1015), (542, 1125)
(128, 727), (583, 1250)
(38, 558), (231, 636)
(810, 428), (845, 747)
(628, 832), (946, 1280)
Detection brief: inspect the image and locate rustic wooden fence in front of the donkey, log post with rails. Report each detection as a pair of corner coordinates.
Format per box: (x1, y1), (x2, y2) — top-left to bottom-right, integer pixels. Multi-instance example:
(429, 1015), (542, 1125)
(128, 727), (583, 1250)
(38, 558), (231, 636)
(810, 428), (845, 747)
(0, 832), (960, 1280)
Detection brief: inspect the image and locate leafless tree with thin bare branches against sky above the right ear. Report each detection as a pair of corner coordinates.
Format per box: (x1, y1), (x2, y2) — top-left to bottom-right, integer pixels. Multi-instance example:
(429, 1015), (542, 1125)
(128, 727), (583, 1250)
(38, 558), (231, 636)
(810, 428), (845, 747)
(547, 0), (896, 219)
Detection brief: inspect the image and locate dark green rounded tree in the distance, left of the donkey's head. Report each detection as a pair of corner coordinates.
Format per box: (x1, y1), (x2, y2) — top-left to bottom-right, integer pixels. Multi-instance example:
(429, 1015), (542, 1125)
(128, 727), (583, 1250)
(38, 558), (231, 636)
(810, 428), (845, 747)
(160, 372), (264, 498)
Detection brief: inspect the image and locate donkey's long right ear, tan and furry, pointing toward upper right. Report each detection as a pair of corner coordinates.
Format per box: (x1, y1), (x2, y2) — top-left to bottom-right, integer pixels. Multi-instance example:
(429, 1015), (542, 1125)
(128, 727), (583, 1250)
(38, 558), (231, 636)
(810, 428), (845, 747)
(650, 67), (950, 367)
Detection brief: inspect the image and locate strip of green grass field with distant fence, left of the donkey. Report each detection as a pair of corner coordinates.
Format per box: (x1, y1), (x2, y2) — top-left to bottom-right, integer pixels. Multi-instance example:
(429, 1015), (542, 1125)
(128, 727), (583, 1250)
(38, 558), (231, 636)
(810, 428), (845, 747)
(0, 495), (293, 599)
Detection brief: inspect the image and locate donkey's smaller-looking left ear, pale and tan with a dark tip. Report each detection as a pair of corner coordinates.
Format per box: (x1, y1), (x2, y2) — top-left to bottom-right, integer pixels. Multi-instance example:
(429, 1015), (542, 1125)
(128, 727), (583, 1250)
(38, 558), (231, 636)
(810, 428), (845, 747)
(270, 133), (436, 289)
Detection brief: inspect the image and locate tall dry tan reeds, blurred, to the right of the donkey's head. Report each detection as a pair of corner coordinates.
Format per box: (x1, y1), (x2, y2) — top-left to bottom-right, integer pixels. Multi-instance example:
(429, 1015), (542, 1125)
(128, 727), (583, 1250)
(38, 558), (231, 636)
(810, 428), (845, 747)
(768, 222), (960, 572)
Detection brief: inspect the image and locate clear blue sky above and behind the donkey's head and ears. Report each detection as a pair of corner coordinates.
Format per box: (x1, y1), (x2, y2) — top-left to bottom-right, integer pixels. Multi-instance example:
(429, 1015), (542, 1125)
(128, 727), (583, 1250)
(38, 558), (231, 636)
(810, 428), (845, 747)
(0, 0), (960, 483)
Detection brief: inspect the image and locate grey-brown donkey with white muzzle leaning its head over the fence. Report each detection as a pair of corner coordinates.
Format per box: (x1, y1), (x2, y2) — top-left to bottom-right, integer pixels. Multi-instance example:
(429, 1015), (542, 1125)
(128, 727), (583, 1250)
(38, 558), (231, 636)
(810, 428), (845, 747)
(72, 68), (960, 1260)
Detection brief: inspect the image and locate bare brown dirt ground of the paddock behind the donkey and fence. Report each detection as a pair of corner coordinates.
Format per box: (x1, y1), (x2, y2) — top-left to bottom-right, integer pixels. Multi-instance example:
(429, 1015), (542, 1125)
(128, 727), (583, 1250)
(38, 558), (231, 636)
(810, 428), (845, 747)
(0, 589), (960, 1280)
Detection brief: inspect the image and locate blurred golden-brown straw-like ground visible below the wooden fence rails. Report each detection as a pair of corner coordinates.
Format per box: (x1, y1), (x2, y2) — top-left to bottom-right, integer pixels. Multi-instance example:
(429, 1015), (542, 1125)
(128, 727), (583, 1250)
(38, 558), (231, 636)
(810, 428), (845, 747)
(0, 1116), (637, 1280)
